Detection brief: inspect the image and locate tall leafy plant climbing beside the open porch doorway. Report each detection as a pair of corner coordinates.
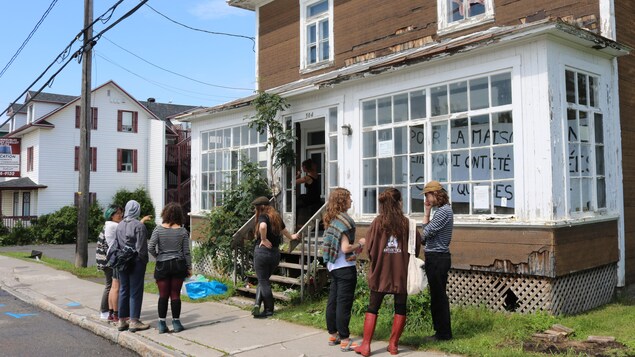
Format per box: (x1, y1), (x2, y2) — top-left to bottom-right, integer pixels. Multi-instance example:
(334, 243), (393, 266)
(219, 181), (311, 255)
(248, 91), (296, 200)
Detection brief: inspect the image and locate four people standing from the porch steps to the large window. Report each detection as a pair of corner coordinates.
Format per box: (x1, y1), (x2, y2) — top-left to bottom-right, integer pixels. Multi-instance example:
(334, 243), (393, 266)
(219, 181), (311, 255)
(247, 181), (454, 356)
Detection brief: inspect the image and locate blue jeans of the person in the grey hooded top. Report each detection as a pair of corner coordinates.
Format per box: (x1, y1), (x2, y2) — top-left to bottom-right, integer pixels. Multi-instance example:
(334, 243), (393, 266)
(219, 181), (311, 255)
(119, 258), (147, 320)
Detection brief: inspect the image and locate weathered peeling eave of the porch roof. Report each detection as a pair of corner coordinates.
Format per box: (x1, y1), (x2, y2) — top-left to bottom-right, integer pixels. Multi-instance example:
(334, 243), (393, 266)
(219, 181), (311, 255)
(176, 18), (631, 121)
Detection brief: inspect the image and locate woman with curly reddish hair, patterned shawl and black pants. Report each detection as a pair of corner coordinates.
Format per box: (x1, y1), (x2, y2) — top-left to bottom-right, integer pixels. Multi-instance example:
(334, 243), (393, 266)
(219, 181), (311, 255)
(322, 188), (366, 352)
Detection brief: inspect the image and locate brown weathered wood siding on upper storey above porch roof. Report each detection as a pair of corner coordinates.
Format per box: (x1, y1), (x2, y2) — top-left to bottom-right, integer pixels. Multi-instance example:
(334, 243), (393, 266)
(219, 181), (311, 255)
(258, 0), (600, 89)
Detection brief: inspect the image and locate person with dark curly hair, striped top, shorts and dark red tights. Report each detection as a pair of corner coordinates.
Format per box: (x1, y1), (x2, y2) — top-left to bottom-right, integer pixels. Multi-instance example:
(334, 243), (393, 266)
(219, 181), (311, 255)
(148, 202), (192, 333)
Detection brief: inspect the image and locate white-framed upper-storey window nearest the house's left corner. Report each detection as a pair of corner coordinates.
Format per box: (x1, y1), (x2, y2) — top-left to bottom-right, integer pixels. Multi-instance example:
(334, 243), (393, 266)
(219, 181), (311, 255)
(300, 0), (335, 73)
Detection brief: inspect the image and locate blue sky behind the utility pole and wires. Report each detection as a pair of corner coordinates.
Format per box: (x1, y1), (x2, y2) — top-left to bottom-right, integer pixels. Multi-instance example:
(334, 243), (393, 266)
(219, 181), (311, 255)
(0, 0), (255, 115)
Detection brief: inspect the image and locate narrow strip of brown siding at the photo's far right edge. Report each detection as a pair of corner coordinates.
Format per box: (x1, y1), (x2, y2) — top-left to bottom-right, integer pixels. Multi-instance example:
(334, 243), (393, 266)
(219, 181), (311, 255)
(615, 1), (635, 285)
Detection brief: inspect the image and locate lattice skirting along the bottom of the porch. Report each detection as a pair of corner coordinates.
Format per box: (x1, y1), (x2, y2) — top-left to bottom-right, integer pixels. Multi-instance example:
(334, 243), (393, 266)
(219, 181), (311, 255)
(448, 264), (617, 315)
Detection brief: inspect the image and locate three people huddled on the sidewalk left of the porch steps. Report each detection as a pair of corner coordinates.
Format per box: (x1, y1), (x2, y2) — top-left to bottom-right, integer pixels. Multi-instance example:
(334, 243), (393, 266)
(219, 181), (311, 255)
(96, 200), (192, 333)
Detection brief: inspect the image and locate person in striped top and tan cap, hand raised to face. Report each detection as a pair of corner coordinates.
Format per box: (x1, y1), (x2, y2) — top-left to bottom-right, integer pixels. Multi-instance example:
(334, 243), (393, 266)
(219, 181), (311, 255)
(423, 181), (454, 341)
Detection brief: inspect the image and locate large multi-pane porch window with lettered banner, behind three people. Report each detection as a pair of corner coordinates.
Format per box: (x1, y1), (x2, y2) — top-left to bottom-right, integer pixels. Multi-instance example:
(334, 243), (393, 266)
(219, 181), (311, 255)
(362, 73), (514, 214)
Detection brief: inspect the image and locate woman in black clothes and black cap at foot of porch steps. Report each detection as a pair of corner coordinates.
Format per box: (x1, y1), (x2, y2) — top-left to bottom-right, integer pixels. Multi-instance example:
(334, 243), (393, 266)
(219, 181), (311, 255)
(251, 196), (298, 318)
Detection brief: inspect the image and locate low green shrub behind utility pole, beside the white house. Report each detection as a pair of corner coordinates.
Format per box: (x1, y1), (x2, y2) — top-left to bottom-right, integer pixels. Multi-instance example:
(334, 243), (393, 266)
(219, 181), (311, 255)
(32, 203), (104, 244)
